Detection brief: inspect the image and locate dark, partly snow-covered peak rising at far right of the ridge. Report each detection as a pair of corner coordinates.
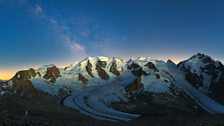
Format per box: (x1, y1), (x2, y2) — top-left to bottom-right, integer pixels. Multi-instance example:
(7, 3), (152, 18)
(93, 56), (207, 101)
(178, 53), (224, 96)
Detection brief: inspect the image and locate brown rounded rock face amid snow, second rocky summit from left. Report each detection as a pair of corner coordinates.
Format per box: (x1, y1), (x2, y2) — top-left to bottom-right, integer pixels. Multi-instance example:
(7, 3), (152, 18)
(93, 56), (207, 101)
(43, 66), (61, 83)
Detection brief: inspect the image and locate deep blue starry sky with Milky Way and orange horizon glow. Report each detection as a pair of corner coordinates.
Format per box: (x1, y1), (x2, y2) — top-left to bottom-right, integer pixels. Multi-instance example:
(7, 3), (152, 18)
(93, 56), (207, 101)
(0, 0), (224, 79)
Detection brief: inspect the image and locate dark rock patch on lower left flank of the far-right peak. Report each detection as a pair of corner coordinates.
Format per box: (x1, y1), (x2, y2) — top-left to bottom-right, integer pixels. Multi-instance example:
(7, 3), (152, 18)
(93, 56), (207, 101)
(185, 71), (203, 89)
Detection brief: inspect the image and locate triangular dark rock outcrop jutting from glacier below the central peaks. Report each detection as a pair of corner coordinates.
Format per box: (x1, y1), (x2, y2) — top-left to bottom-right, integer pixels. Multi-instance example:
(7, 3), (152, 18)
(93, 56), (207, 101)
(125, 76), (144, 92)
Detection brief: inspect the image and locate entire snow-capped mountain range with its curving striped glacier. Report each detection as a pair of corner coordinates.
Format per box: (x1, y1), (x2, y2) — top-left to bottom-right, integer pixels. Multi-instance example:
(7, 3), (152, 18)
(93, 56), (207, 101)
(0, 53), (224, 125)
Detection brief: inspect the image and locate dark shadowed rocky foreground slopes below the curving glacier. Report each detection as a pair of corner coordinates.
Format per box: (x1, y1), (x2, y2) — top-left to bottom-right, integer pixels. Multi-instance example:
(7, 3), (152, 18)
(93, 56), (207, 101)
(0, 93), (224, 126)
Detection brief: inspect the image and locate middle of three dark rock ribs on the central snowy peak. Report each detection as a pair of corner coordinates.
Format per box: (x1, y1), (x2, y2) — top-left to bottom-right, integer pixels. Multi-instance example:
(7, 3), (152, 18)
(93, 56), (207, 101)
(96, 60), (110, 80)
